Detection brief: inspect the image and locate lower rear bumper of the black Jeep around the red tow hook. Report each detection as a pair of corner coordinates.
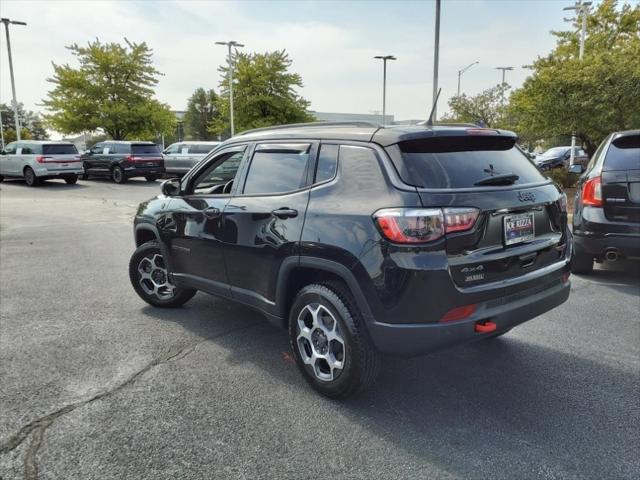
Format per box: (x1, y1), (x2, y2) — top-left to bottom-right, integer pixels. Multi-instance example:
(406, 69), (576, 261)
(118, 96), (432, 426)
(369, 279), (571, 356)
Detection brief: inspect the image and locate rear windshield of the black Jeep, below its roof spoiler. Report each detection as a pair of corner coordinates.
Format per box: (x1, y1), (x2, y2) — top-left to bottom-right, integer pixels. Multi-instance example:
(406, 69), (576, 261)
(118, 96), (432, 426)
(388, 136), (545, 188)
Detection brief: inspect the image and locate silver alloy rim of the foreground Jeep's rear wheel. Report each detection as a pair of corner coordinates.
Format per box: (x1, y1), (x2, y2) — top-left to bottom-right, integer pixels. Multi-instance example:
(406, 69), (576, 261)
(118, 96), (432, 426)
(297, 303), (346, 382)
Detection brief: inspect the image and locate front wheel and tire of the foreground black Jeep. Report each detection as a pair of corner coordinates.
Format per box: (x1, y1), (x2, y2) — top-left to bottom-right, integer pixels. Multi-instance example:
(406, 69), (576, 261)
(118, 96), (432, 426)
(129, 241), (197, 308)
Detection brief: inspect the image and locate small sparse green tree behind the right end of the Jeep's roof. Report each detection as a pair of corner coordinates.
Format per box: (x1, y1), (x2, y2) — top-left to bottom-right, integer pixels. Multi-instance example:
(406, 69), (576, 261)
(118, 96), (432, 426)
(449, 84), (509, 128)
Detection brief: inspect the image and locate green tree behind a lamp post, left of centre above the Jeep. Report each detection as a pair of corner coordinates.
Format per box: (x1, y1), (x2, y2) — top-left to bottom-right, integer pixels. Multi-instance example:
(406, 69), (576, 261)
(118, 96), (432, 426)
(209, 50), (314, 136)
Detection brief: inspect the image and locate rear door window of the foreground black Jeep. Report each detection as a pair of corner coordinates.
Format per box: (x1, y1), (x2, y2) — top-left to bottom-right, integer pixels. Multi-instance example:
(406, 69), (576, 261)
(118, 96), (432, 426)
(244, 144), (311, 195)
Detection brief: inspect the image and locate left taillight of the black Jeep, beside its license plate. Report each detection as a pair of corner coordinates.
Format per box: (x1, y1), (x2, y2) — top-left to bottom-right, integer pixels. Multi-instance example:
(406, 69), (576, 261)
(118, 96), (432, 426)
(373, 208), (479, 244)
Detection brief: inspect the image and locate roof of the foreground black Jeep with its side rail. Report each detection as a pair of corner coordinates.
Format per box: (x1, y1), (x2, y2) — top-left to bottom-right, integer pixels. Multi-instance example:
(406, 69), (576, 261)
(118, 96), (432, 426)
(229, 122), (516, 147)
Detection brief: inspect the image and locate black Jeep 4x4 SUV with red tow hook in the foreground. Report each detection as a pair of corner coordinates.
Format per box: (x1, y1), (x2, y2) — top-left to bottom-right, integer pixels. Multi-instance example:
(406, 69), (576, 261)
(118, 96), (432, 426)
(129, 124), (572, 397)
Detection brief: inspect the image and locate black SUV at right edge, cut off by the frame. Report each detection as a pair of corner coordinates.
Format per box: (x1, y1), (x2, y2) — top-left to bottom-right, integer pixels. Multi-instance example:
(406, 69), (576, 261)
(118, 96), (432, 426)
(570, 130), (640, 273)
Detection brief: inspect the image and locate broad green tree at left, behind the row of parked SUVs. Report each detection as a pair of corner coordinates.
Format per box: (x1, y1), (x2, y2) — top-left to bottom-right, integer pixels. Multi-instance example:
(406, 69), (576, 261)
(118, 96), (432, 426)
(43, 39), (175, 140)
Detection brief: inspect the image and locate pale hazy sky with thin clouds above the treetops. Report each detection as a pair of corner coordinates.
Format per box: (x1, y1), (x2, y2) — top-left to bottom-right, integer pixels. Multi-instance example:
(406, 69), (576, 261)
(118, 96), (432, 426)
(0, 0), (570, 124)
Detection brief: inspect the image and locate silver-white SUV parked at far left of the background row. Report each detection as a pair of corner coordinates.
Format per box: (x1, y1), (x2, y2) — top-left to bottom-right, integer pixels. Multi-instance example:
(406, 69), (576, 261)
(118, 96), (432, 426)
(0, 140), (83, 187)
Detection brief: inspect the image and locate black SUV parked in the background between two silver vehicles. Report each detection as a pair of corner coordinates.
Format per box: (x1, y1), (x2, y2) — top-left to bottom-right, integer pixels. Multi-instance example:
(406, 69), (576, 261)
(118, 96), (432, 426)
(82, 140), (164, 183)
